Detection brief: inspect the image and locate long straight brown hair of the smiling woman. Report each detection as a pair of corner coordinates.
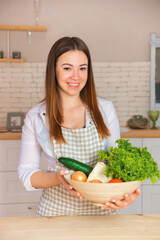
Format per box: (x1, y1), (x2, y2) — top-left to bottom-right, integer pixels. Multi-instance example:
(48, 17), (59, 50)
(45, 37), (110, 143)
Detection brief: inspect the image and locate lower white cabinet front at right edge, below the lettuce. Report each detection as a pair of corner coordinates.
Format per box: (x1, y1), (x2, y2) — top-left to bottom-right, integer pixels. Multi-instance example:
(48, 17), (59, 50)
(142, 184), (160, 214)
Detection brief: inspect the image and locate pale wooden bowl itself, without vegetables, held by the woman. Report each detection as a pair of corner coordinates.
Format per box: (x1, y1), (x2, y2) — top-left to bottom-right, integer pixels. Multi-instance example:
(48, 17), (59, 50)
(64, 171), (142, 206)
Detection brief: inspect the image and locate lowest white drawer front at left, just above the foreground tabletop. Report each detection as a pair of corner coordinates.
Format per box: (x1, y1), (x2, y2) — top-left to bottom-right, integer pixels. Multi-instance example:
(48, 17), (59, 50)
(0, 203), (38, 217)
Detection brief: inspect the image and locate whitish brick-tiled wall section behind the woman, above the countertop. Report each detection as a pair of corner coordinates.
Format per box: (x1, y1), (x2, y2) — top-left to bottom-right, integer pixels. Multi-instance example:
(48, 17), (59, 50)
(0, 62), (150, 127)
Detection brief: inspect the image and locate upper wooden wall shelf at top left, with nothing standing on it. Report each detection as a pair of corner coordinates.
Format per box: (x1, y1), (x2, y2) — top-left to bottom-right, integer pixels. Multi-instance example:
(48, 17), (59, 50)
(0, 25), (47, 32)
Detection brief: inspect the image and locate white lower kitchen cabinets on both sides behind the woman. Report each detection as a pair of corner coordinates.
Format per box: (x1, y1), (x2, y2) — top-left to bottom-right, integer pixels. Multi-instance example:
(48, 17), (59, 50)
(0, 136), (160, 217)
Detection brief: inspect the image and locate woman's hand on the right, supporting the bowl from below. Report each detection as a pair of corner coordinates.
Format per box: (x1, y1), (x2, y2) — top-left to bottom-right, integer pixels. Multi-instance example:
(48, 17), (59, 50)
(101, 188), (142, 210)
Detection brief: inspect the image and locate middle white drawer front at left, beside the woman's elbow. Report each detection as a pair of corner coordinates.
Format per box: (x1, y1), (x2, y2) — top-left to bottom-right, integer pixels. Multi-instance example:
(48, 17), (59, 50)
(0, 172), (41, 204)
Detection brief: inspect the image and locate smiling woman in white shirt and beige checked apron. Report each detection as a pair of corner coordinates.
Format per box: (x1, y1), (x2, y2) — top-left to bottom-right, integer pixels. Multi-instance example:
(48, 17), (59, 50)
(18, 37), (140, 216)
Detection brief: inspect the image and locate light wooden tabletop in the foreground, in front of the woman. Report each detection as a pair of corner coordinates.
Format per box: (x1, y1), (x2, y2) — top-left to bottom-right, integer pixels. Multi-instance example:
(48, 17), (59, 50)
(0, 214), (160, 240)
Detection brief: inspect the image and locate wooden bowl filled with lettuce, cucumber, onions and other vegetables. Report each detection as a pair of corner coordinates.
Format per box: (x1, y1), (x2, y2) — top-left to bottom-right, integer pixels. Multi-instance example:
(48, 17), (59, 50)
(60, 139), (160, 205)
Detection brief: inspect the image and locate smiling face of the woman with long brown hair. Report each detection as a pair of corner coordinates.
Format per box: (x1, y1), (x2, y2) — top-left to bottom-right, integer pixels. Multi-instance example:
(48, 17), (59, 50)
(56, 50), (88, 96)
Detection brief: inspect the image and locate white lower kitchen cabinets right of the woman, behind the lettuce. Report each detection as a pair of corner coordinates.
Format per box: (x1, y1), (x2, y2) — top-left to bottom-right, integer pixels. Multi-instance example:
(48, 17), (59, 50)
(117, 138), (160, 214)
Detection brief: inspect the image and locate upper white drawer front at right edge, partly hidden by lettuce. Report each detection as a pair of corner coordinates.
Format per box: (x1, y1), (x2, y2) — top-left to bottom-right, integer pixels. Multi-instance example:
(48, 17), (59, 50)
(143, 138), (160, 184)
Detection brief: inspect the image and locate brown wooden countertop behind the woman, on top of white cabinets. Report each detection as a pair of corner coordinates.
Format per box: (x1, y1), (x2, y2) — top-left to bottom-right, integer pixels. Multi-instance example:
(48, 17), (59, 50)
(0, 128), (160, 140)
